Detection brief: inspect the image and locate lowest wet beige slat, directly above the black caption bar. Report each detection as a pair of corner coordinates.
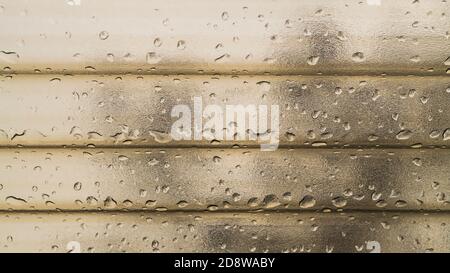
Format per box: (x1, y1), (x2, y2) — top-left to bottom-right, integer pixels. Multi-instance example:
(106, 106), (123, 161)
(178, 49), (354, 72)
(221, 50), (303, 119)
(0, 209), (450, 252)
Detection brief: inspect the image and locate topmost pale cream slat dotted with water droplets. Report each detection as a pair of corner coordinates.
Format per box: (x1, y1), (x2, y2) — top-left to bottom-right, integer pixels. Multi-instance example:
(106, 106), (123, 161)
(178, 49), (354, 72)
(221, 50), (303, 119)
(0, 0), (450, 75)
